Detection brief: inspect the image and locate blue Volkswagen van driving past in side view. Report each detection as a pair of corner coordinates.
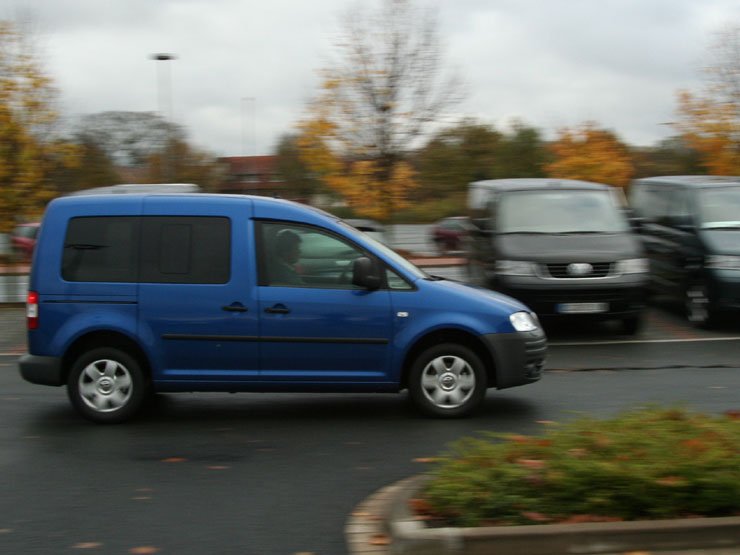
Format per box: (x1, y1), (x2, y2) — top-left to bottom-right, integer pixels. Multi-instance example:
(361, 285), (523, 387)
(19, 193), (546, 423)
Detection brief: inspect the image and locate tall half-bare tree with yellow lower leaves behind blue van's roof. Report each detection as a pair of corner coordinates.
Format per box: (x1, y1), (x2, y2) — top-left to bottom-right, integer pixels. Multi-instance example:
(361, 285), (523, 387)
(299, 0), (459, 219)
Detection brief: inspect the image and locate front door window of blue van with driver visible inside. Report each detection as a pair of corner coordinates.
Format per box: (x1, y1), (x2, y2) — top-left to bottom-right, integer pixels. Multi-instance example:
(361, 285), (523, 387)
(257, 222), (364, 289)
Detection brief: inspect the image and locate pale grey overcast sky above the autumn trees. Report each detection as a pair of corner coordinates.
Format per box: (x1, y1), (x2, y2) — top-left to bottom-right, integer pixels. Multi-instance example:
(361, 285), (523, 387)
(0, 0), (740, 156)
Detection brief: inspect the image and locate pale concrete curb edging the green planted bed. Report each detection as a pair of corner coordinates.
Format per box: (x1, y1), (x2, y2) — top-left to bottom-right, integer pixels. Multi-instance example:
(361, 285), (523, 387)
(345, 475), (740, 555)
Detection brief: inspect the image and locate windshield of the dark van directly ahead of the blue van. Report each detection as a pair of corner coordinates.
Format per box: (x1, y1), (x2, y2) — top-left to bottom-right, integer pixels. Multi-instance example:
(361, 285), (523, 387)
(495, 190), (628, 233)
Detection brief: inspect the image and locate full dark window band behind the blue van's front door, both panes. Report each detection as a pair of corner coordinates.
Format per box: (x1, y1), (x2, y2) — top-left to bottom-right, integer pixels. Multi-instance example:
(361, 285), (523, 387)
(62, 216), (231, 283)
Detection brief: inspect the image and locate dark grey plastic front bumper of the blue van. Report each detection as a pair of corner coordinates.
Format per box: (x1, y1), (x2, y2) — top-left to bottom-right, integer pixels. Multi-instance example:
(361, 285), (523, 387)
(483, 329), (547, 389)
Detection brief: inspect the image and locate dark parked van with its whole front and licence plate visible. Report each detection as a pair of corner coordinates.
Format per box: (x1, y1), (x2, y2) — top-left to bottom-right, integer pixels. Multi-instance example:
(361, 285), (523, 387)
(469, 178), (648, 334)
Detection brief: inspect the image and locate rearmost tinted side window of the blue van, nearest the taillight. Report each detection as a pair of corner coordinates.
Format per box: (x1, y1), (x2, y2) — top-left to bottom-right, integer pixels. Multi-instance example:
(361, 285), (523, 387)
(62, 216), (139, 282)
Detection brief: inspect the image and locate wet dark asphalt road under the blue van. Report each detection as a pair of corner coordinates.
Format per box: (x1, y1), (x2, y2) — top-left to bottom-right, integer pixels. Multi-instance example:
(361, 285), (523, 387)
(0, 305), (740, 555)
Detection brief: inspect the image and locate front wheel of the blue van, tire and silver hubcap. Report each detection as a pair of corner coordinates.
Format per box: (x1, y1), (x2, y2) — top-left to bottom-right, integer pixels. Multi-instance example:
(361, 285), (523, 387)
(409, 343), (487, 418)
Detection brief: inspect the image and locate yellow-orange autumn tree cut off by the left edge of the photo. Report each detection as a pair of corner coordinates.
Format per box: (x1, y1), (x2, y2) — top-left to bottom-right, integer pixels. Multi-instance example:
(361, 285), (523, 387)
(0, 20), (77, 231)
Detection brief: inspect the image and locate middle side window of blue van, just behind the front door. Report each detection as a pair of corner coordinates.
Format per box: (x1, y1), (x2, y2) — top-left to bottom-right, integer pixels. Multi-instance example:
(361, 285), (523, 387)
(140, 216), (231, 283)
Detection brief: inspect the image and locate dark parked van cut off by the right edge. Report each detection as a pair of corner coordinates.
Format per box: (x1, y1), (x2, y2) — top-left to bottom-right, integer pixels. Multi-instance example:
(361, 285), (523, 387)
(629, 176), (740, 327)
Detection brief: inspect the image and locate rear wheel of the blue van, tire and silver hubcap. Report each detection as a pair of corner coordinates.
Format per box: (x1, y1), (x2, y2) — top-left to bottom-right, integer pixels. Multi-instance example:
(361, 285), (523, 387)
(67, 347), (151, 424)
